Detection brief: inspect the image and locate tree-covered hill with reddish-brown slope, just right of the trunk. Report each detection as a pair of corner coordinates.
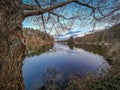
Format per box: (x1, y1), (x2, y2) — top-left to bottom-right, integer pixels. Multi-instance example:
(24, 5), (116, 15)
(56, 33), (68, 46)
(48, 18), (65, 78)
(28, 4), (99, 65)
(22, 28), (54, 45)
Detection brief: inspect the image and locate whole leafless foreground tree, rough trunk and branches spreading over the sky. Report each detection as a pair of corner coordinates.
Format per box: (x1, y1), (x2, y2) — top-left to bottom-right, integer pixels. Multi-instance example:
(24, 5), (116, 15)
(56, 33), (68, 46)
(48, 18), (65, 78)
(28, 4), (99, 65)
(0, 0), (120, 90)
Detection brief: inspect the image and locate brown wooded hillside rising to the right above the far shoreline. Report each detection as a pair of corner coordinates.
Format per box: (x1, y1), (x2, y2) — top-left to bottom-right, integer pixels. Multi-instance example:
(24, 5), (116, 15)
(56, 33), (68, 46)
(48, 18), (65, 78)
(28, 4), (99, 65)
(75, 23), (120, 44)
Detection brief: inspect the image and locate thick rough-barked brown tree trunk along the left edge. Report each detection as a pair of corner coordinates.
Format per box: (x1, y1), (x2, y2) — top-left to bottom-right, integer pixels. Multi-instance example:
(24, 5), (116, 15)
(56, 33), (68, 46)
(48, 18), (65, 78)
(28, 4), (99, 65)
(0, 0), (25, 90)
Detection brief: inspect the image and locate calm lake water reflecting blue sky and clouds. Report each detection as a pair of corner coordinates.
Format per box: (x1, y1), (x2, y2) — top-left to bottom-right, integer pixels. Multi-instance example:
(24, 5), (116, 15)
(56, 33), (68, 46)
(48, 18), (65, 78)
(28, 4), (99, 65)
(22, 43), (109, 90)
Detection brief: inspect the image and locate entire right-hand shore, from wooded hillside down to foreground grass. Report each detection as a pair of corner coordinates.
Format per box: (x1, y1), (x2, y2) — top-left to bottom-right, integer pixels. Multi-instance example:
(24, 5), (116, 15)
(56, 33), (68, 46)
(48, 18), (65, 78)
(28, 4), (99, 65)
(71, 23), (120, 90)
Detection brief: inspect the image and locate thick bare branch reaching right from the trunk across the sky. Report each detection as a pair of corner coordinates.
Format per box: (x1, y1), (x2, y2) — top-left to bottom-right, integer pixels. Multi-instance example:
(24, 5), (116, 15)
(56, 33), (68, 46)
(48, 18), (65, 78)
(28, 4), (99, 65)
(23, 0), (95, 17)
